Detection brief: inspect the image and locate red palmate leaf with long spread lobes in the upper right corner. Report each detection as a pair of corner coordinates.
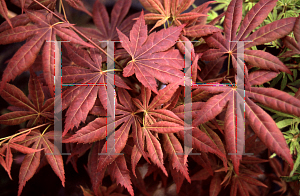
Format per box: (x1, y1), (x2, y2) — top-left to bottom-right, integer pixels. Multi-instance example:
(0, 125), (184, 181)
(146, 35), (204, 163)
(201, 0), (296, 80)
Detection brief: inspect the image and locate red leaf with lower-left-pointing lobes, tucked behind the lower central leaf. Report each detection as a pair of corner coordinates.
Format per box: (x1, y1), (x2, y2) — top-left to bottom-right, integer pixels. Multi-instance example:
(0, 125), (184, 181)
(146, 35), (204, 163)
(64, 89), (143, 175)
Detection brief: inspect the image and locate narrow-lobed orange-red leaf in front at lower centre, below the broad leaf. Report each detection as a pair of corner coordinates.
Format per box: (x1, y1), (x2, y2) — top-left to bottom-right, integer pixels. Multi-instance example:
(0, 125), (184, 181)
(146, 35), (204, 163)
(98, 83), (183, 175)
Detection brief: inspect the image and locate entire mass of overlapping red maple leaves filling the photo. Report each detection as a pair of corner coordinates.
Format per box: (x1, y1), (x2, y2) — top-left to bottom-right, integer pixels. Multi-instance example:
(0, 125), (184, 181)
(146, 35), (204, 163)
(0, 0), (300, 196)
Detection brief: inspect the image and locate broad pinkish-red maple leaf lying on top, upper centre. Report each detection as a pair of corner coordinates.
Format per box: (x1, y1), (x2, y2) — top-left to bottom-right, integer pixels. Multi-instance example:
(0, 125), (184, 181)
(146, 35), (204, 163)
(117, 12), (184, 93)
